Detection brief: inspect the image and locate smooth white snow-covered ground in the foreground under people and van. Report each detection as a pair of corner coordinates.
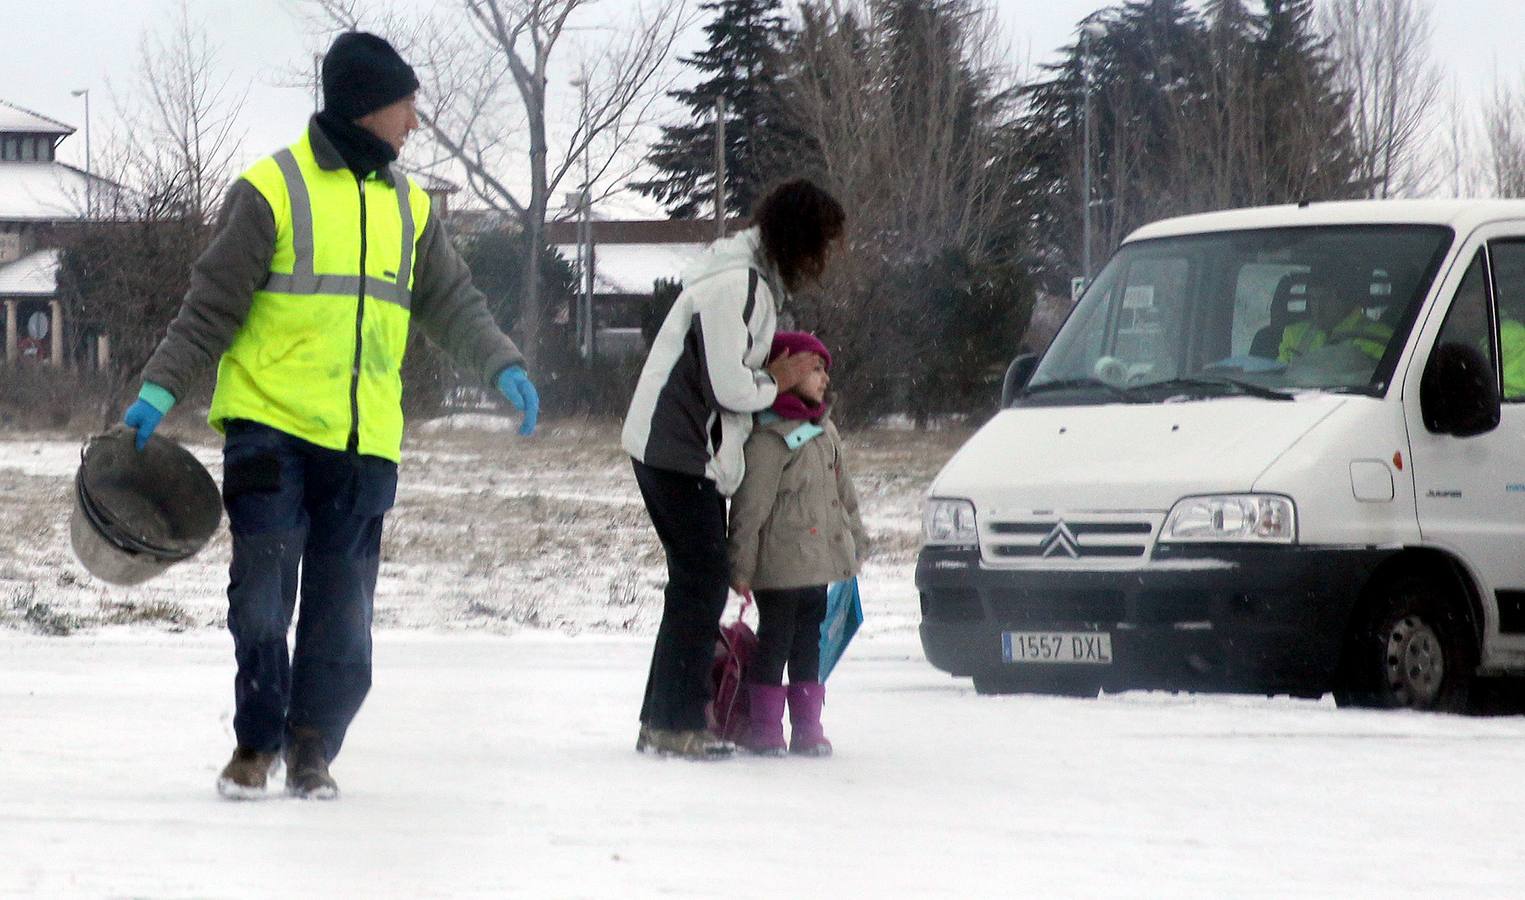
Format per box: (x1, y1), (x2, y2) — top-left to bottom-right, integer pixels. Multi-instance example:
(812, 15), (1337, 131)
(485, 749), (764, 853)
(0, 628), (1525, 898)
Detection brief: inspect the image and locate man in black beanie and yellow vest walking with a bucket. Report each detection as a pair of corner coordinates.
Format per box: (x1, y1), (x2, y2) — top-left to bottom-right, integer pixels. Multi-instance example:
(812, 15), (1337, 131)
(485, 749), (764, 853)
(124, 32), (540, 799)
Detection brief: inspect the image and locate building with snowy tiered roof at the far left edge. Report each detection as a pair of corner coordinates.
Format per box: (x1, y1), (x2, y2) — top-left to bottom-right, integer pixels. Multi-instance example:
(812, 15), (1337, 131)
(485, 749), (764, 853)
(0, 101), (116, 365)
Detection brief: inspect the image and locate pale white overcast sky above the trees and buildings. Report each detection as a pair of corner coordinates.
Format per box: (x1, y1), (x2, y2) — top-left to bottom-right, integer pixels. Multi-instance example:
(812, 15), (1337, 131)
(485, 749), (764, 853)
(0, 0), (1525, 215)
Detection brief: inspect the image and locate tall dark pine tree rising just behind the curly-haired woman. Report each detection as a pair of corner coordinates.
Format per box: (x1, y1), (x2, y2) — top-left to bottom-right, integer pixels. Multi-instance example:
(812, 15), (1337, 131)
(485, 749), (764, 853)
(631, 0), (788, 218)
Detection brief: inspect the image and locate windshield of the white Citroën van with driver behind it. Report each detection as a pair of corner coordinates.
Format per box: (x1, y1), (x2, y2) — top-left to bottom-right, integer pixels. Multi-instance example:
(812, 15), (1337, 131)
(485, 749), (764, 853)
(1017, 226), (1452, 404)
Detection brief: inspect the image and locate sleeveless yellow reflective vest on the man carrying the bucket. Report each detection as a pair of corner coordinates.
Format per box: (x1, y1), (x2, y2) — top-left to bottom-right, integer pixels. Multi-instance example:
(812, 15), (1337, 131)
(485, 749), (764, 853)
(207, 131), (430, 462)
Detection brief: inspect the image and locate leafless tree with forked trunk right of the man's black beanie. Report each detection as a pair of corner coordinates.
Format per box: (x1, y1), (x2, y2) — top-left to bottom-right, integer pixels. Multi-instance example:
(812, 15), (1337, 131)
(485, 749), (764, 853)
(310, 0), (691, 368)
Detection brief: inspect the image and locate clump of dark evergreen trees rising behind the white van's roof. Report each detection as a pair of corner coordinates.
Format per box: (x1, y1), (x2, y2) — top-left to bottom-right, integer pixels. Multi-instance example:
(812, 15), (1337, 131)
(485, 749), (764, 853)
(1017, 0), (1356, 293)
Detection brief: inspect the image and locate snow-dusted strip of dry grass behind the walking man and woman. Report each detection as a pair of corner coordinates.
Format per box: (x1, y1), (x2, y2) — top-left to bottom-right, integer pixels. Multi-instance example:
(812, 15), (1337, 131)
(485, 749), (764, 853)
(0, 416), (961, 633)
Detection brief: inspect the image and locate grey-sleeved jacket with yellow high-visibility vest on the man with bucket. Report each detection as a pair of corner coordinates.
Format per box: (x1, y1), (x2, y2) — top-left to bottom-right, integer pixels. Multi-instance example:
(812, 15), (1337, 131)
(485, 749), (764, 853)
(143, 116), (523, 462)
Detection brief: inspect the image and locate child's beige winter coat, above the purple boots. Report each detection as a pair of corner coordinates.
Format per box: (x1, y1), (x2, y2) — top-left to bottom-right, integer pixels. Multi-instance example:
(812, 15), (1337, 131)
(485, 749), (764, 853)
(729, 415), (869, 590)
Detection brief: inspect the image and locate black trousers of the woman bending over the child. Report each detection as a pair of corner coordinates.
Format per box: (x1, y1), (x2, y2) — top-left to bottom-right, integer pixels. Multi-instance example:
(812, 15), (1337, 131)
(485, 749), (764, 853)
(631, 459), (730, 731)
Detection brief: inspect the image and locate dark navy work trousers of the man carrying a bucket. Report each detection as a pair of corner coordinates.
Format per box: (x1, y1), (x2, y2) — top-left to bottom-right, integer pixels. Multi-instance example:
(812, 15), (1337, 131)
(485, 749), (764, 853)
(223, 421), (397, 760)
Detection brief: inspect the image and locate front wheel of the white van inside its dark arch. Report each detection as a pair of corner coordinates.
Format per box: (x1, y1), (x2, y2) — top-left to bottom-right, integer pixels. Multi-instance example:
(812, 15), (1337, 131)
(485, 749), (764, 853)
(1334, 574), (1478, 712)
